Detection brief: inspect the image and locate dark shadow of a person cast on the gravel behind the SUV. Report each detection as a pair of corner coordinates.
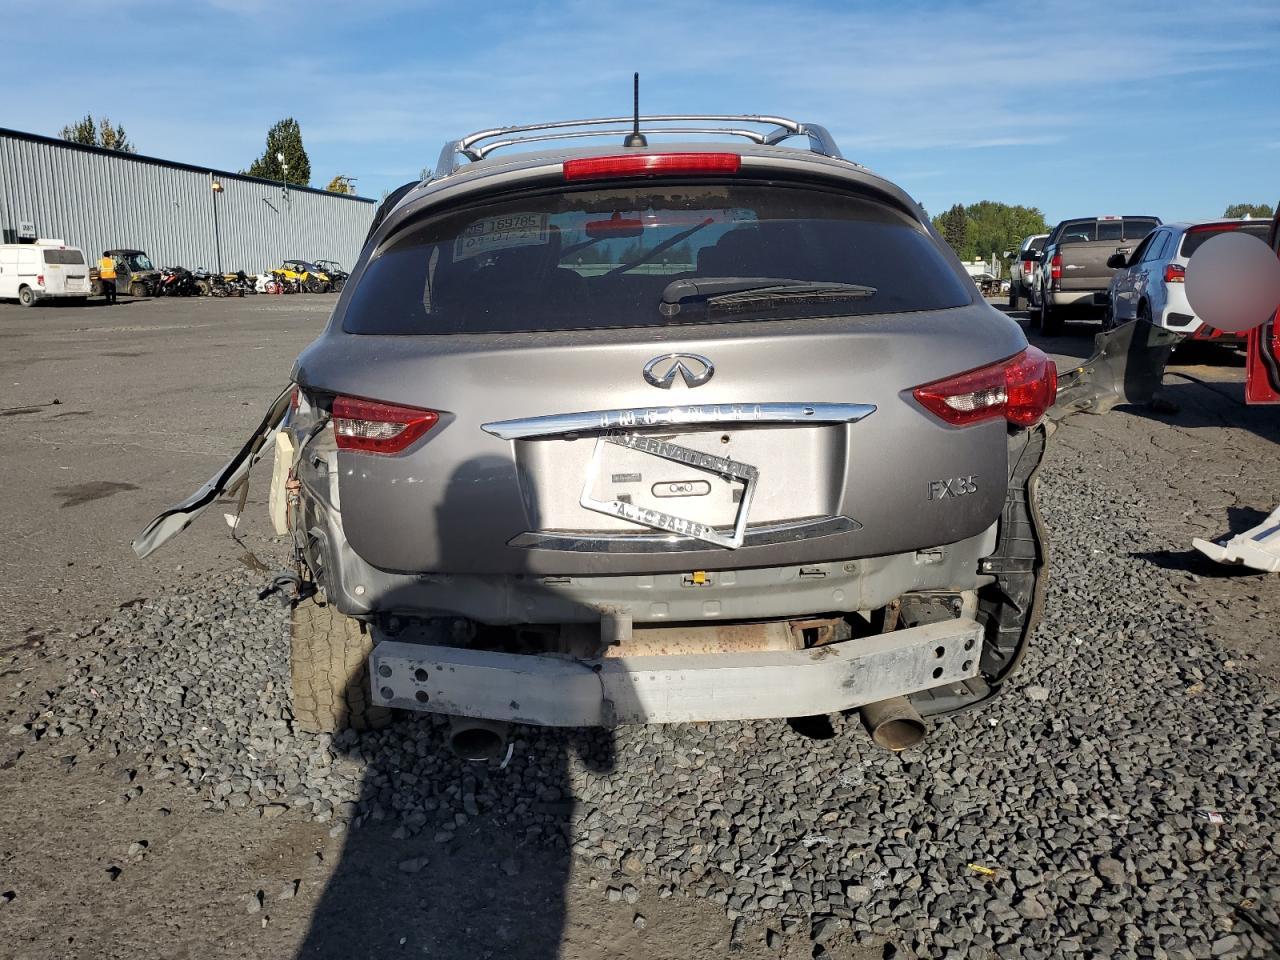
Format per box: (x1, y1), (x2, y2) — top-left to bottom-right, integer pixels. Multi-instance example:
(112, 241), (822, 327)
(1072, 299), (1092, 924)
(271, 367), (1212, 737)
(297, 457), (624, 960)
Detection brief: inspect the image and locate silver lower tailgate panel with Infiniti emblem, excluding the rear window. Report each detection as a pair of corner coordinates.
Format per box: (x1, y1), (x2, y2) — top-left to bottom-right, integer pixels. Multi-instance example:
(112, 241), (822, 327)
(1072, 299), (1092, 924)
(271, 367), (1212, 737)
(307, 317), (1020, 573)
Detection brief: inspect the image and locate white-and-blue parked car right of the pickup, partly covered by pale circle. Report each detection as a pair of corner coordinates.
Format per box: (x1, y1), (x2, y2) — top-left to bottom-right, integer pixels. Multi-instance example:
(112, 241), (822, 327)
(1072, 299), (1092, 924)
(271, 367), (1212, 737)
(1102, 220), (1271, 343)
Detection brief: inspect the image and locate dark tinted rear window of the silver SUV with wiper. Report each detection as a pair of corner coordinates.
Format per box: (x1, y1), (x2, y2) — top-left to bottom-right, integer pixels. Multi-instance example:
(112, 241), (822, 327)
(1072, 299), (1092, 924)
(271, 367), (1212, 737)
(343, 183), (970, 334)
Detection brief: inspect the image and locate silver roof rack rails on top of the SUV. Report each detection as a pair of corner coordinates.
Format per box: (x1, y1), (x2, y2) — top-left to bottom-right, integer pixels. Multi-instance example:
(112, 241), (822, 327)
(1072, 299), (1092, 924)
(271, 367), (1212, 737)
(435, 114), (842, 177)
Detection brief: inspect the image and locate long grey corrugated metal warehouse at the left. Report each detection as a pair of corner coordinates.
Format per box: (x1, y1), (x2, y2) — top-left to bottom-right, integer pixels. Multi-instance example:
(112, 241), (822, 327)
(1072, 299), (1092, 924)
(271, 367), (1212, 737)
(0, 128), (376, 273)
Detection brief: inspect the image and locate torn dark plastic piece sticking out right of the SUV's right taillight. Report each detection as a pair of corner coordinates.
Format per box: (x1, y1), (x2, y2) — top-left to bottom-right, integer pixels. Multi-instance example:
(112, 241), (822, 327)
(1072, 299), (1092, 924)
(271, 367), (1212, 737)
(1048, 320), (1183, 420)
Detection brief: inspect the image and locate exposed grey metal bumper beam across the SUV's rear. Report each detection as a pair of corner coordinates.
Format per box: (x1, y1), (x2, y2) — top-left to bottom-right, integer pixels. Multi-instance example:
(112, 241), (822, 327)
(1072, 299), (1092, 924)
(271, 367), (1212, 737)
(369, 618), (983, 727)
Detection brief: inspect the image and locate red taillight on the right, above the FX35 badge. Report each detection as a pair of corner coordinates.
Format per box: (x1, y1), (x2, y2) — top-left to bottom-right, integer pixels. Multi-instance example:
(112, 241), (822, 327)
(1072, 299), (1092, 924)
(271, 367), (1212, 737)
(911, 347), (1057, 426)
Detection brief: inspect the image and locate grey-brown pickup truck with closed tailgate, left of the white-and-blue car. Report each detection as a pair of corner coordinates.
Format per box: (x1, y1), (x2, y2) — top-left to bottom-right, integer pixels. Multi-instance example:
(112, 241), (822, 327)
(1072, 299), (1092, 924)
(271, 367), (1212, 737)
(1029, 216), (1160, 337)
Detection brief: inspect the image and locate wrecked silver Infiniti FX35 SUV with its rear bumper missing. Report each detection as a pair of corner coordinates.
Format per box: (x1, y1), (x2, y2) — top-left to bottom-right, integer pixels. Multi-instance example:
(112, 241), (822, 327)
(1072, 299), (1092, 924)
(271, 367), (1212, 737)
(134, 116), (1056, 756)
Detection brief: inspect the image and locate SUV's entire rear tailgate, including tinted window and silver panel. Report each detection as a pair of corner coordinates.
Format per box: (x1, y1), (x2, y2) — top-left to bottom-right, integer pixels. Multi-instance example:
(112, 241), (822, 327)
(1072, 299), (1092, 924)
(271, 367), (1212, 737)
(304, 170), (1025, 575)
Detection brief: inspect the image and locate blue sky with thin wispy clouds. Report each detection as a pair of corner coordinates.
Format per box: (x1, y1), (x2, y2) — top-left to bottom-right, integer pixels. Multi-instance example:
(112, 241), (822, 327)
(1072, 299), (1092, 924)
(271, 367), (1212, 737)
(10, 0), (1280, 223)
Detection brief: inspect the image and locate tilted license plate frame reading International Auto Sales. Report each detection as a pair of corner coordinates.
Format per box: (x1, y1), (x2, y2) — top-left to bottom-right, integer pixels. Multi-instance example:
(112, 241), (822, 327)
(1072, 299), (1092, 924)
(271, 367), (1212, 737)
(579, 434), (759, 550)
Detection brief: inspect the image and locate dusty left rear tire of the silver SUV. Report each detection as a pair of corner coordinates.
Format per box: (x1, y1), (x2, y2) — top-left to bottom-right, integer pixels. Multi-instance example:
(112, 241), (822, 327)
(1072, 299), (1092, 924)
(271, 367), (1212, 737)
(289, 598), (392, 733)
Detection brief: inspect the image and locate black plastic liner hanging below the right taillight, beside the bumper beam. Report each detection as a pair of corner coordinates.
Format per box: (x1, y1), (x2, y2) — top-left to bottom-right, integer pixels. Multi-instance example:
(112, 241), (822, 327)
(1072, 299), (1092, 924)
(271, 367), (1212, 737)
(909, 424), (1050, 717)
